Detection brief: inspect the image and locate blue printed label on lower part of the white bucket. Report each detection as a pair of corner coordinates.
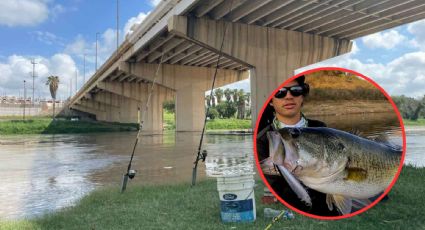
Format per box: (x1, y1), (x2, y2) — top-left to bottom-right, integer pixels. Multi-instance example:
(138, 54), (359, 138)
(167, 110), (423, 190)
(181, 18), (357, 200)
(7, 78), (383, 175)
(221, 199), (254, 222)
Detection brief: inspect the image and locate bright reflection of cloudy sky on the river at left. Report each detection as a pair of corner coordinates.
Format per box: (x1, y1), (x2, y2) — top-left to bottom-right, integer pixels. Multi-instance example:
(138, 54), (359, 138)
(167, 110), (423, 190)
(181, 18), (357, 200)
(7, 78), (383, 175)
(0, 136), (120, 217)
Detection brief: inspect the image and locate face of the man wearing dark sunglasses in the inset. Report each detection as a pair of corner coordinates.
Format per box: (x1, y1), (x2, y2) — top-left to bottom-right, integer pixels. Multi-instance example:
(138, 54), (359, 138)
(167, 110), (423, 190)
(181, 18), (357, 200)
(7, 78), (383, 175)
(271, 81), (304, 119)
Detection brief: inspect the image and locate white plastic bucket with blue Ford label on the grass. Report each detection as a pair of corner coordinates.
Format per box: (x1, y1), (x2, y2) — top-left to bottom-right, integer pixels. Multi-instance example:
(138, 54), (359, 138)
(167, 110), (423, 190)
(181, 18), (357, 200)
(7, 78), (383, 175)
(217, 174), (256, 222)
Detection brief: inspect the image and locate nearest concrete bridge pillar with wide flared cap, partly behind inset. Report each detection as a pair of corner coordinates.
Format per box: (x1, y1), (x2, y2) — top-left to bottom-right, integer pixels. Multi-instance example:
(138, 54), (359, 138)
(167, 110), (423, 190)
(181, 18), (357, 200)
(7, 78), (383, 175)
(168, 16), (352, 127)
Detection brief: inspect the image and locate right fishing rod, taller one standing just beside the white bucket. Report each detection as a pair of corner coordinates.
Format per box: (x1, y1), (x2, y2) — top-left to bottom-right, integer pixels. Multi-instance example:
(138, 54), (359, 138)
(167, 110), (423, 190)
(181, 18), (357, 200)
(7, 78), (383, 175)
(192, 0), (234, 186)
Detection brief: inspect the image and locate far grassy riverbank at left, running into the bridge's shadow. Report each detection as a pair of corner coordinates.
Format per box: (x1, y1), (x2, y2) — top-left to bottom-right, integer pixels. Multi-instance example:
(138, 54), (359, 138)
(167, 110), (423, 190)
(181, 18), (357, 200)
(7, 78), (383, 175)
(0, 118), (137, 135)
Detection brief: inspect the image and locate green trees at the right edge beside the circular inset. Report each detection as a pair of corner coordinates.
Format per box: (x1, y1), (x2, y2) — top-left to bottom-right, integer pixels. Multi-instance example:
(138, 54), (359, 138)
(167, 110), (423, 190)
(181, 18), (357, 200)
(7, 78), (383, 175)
(391, 95), (425, 121)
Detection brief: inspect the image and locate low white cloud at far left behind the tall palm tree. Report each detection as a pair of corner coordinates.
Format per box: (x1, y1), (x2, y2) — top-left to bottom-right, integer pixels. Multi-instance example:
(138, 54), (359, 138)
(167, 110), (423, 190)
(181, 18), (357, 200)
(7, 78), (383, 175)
(0, 53), (78, 99)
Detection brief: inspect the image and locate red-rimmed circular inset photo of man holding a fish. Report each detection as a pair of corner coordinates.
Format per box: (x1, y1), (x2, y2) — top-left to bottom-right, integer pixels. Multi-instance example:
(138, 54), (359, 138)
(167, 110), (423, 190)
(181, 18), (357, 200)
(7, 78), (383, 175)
(254, 68), (406, 219)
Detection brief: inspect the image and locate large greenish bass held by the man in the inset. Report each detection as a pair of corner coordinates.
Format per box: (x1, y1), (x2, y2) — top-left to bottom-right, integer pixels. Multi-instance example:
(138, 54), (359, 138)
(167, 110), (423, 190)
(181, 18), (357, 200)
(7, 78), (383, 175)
(266, 127), (403, 215)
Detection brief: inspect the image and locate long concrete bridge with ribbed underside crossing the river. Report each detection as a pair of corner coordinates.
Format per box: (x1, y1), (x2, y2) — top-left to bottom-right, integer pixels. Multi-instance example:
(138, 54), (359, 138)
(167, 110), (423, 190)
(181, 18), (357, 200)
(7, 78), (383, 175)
(70, 0), (425, 131)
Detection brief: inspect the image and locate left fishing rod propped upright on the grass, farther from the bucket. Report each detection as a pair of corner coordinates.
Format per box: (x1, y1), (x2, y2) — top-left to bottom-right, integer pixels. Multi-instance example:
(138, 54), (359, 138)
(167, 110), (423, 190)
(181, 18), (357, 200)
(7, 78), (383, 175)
(121, 53), (164, 193)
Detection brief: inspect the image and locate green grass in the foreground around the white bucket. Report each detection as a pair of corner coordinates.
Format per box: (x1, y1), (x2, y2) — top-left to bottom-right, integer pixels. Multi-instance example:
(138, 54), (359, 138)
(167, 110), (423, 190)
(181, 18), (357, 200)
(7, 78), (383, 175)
(0, 166), (425, 230)
